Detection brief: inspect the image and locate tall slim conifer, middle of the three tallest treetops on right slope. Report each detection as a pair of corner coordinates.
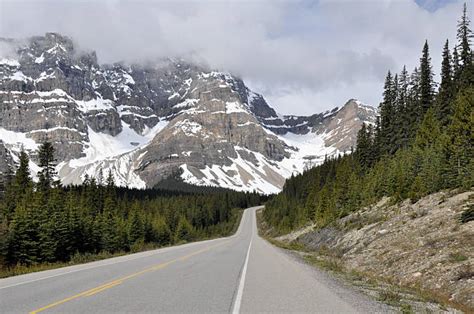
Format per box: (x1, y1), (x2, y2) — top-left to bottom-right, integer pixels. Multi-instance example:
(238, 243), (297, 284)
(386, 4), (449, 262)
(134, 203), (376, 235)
(436, 40), (454, 126)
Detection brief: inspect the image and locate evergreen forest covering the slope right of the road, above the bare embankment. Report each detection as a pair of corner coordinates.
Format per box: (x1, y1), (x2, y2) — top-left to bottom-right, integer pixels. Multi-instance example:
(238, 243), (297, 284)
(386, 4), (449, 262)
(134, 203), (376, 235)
(264, 5), (474, 233)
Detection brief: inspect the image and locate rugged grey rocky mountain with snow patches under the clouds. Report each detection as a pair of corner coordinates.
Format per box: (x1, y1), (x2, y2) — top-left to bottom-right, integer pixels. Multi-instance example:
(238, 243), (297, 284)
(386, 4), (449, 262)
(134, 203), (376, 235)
(0, 33), (377, 193)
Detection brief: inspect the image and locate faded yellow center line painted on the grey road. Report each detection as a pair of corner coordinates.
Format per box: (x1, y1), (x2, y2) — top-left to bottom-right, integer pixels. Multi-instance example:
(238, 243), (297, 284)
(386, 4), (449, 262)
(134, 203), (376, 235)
(30, 241), (229, 314)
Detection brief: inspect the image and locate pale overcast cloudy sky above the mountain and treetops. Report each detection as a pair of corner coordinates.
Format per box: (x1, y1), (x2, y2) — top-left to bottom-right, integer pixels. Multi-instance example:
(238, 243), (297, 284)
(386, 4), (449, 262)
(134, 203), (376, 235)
(0, 0), (472, 114)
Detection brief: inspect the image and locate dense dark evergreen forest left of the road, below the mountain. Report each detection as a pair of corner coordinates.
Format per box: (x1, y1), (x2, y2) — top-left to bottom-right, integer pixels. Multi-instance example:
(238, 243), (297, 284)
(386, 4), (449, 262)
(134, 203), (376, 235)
(0, 142), (261, 270)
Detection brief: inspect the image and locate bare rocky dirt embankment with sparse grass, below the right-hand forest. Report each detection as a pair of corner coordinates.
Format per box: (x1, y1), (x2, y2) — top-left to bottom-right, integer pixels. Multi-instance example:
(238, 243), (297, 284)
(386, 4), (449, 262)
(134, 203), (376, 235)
(272, 191), (474, 312)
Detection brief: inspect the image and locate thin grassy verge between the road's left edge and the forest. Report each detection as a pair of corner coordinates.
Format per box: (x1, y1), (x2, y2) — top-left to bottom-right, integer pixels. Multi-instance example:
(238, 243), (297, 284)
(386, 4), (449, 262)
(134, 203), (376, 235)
(0, 209), (244, 279)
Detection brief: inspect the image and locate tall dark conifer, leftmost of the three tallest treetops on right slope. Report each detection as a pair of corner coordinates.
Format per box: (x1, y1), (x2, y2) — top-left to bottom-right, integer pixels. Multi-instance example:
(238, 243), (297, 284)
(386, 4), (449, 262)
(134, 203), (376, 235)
(417, 41), (434, 119)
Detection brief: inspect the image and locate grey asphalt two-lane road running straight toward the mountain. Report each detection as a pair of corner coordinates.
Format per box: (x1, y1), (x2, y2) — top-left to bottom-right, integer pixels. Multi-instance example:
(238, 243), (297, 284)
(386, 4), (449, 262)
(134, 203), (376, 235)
(0, 207), (386, 313)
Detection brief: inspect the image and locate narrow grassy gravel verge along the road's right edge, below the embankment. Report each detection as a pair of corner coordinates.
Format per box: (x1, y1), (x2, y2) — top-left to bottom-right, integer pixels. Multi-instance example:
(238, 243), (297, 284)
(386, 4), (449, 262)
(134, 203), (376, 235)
(257, 210), (462, 313)
